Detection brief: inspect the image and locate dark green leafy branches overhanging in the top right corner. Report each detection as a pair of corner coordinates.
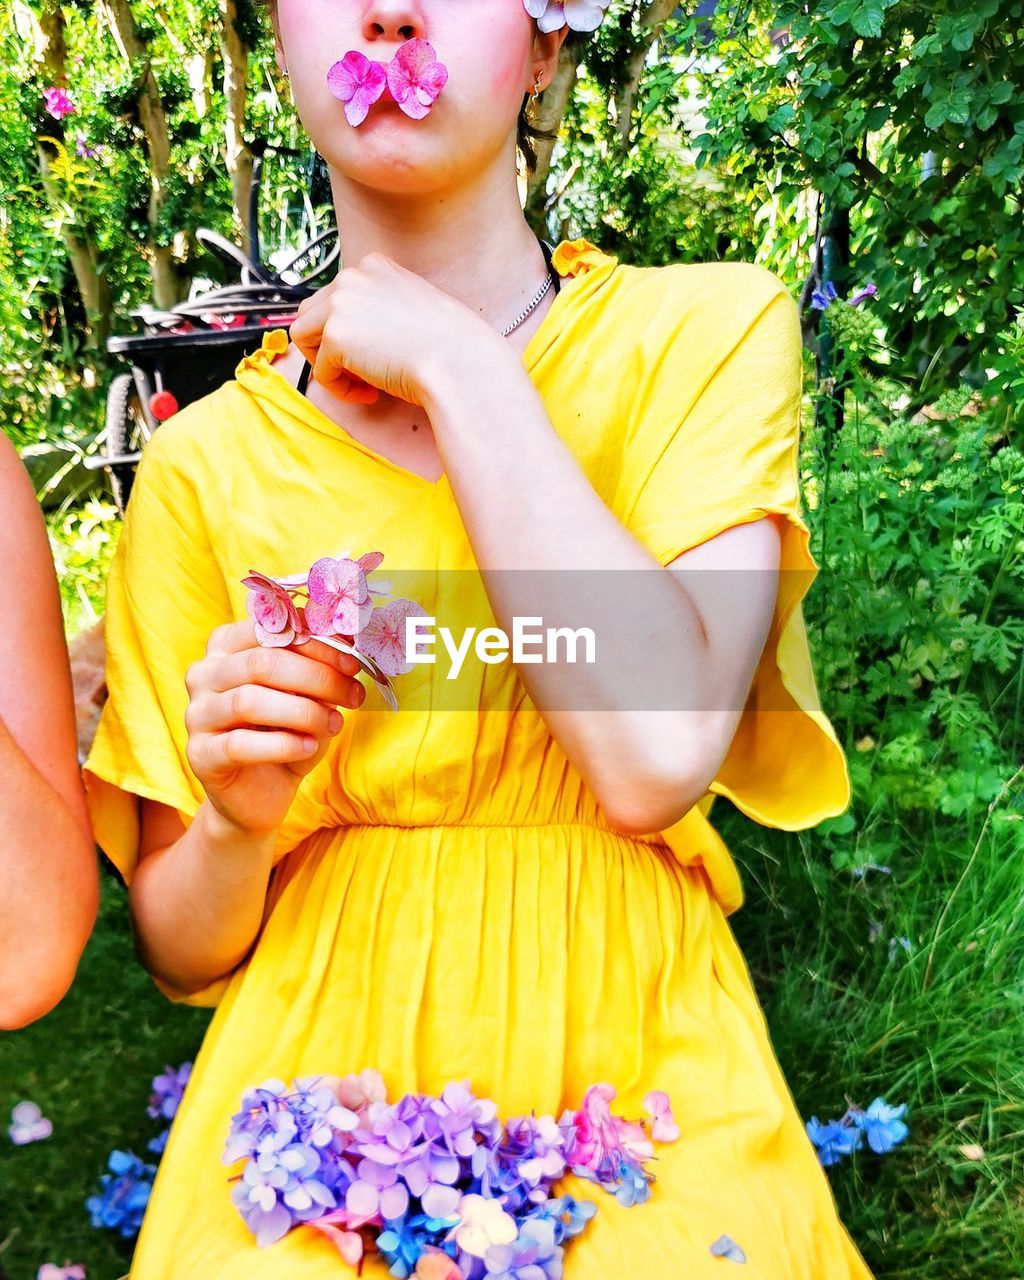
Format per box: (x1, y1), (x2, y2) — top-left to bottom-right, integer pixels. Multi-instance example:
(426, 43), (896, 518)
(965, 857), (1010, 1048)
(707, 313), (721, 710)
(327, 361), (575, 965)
(671, 0), (1024, 398)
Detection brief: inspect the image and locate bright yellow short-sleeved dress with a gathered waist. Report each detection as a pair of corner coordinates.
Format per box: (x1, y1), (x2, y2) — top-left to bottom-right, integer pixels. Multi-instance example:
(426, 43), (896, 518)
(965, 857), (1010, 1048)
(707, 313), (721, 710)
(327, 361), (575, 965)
(84, 241), (869, 1280)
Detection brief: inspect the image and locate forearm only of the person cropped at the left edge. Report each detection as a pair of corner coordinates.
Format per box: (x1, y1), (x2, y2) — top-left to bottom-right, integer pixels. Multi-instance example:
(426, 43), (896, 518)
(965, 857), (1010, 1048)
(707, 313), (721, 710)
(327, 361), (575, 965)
(0, 717), (99, 1030)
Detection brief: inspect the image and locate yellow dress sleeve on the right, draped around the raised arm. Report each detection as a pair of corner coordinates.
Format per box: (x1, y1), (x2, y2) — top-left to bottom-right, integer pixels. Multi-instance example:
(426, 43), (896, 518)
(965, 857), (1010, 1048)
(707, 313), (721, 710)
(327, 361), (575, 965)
(627, 264), (851, 909)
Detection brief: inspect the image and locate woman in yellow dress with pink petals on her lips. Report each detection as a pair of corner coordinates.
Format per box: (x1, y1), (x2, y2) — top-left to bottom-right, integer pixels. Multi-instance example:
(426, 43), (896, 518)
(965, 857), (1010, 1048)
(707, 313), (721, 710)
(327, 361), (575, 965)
(86, 0), (869, 1280)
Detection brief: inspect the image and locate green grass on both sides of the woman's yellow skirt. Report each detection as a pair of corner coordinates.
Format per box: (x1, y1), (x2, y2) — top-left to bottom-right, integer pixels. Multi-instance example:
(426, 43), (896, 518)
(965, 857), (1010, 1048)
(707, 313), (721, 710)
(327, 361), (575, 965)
(0, 788), (1024, 1280)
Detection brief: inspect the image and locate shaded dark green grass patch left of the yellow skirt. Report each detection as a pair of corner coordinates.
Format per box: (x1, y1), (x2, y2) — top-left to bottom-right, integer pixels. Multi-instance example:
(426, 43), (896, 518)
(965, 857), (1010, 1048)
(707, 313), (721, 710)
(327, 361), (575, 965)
(0, 874), (210, 1280)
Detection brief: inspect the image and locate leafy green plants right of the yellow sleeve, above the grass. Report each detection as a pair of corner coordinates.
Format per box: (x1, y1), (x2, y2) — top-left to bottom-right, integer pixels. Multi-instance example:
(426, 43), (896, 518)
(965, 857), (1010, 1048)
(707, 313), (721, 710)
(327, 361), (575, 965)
(804, 302), (1024, 818)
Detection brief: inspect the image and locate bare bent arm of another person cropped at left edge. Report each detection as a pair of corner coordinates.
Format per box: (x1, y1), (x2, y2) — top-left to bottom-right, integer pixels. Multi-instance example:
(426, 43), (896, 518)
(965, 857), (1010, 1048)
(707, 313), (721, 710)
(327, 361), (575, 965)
(0, 433), (99, 1030)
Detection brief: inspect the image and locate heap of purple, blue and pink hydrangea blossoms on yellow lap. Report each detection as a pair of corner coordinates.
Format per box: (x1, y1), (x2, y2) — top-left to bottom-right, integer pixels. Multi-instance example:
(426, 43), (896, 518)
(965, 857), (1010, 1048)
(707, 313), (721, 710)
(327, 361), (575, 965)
(223, 1076), (686, 1280)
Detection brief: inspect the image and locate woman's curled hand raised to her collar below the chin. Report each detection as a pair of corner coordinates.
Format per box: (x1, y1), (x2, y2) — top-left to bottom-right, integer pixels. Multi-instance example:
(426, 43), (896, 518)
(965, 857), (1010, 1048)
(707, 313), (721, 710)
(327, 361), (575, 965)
(289, 252), (500, 406)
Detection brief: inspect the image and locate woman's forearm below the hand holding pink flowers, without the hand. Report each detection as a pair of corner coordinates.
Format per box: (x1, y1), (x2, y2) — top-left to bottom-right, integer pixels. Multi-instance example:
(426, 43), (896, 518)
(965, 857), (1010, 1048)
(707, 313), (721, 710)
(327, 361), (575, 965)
(129, 800), (276, 992)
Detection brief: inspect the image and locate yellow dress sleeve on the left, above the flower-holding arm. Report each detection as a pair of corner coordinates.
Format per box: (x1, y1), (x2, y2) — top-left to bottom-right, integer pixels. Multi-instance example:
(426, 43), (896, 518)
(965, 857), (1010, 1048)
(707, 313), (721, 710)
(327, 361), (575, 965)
(83, 411), (232, 1005)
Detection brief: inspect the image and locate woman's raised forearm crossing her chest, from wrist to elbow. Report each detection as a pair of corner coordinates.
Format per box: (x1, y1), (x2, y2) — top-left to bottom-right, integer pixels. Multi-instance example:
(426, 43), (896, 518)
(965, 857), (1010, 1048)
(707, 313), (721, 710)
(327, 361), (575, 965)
(428, 348), (727, 815)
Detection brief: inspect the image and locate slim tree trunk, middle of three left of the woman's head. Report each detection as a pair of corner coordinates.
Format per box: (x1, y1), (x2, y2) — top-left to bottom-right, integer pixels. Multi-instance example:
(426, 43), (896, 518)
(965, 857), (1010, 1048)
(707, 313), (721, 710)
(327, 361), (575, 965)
(97, 0), (188, 310)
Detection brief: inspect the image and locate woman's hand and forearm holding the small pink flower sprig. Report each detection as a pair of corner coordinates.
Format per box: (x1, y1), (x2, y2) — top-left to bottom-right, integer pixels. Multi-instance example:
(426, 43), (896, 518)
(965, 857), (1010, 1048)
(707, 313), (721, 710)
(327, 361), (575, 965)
(129, 620), (366, 993)
